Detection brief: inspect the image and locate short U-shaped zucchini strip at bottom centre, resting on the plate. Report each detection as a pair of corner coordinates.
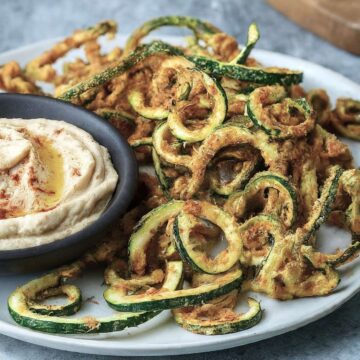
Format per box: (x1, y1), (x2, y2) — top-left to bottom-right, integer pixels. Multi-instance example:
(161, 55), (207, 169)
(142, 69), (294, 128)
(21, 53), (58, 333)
(173, 298), (263, 335)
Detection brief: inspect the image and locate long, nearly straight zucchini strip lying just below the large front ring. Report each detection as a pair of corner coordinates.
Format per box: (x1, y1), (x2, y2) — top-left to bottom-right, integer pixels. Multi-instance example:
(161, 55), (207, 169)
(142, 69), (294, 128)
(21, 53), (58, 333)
(104, 270), (242, 312)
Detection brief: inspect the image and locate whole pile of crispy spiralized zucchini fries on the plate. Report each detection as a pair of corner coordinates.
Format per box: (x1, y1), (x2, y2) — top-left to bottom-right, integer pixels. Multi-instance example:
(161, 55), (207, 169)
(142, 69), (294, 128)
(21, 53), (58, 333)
(0, 16), (360, 335)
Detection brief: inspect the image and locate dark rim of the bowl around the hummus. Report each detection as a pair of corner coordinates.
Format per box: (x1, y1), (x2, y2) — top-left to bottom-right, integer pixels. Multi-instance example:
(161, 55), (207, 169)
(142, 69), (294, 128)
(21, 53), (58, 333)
(0, 93), (138, 261)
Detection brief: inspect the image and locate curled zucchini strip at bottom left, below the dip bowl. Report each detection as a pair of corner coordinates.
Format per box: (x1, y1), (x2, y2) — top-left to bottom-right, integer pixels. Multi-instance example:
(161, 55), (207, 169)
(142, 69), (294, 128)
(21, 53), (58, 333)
(8, 241), (159, 334)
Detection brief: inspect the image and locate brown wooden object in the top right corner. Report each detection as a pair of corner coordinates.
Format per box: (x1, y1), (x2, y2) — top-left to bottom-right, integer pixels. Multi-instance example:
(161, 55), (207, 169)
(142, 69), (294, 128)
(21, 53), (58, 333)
(268, 0), (360, 55)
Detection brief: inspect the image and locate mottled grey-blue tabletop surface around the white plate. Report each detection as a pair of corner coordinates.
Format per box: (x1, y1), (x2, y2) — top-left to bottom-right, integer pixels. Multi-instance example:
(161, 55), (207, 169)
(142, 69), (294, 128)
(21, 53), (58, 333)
(0, 0), (360, 360)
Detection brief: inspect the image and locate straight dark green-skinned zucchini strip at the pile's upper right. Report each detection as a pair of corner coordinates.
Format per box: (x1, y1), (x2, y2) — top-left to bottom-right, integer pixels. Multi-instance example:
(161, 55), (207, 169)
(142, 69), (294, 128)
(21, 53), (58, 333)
(187, 55), (303, 86)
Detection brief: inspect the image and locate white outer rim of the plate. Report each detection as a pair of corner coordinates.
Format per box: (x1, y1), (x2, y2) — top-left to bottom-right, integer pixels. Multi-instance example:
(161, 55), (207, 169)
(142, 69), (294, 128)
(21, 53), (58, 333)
(0, 34), (360, 356)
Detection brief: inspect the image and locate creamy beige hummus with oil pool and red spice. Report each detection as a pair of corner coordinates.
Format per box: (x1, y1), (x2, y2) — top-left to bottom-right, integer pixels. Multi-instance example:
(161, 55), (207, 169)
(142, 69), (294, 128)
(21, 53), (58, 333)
(0, 119), (118, 250)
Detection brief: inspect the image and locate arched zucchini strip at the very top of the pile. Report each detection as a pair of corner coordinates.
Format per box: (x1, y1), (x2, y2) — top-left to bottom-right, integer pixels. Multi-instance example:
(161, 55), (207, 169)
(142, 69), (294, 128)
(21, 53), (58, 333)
(124, 16), (221, 55)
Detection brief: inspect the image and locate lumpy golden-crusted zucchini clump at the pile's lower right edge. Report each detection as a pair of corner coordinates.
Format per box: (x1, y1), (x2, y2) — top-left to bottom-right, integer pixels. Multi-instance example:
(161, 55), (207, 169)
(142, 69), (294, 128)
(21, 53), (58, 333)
(241, 214), (339, 300)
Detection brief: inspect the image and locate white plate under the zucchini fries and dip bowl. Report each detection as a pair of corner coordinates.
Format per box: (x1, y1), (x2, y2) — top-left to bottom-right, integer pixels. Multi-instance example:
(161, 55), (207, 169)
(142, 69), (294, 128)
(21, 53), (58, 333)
(0, 37), (360, 355)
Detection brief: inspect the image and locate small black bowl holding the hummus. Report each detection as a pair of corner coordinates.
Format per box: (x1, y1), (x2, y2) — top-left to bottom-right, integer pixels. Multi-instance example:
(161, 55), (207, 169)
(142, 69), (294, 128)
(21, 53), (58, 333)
(0, 94), (138, 274)
